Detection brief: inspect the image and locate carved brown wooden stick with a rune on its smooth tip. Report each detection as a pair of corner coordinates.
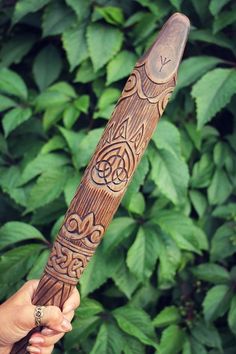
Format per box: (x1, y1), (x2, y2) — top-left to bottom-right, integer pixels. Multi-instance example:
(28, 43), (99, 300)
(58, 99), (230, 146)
(11, 13), (190, 354)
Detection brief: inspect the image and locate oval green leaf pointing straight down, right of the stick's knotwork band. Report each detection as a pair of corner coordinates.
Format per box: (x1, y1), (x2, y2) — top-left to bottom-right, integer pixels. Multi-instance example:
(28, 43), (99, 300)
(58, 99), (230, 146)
(127, 225), (160, 281)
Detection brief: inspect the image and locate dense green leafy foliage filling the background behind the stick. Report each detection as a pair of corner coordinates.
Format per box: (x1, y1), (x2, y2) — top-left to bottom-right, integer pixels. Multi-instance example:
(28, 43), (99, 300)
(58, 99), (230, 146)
(0, 0), (236, 354)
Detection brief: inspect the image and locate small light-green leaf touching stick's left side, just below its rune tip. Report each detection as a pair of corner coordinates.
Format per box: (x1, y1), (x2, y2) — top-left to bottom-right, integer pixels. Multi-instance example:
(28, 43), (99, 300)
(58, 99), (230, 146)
(106, 50), (137, 85)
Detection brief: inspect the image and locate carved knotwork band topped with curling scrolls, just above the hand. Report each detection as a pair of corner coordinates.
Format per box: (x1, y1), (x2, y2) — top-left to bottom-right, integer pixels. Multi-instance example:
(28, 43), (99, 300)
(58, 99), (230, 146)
(45, 213), (104, 284)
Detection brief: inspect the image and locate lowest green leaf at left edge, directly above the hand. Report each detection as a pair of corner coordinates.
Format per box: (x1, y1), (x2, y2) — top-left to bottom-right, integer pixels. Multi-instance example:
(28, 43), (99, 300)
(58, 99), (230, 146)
(0, 244), (44, 284)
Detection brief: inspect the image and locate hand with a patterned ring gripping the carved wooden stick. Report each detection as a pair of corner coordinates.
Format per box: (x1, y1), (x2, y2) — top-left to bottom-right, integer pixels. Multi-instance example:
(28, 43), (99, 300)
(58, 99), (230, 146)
(0, 280), (80, 354)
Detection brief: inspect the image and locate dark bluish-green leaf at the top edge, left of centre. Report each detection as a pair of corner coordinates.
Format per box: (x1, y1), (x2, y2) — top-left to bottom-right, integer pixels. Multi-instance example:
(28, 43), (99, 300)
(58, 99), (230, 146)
(42, 1), (75, 37)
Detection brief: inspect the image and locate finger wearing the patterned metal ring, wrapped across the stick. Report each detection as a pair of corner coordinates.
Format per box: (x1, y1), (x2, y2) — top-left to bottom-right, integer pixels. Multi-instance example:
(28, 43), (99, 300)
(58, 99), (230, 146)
(21, 305), (72, 332)
